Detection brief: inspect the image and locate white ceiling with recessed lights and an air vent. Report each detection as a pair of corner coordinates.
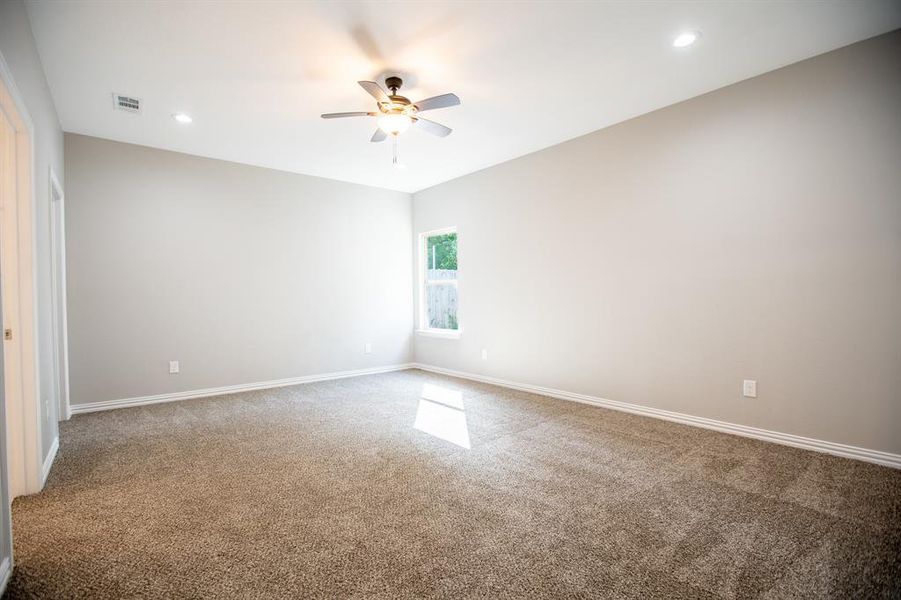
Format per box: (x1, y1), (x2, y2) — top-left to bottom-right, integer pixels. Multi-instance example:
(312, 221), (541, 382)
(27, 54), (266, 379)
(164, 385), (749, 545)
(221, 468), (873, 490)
(29, 0), (901, 192)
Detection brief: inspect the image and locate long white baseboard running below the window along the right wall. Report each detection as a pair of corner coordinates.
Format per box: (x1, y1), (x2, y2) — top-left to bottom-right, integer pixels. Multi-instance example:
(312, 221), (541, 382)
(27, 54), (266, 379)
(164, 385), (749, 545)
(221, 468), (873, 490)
(414, 363), (901, 469)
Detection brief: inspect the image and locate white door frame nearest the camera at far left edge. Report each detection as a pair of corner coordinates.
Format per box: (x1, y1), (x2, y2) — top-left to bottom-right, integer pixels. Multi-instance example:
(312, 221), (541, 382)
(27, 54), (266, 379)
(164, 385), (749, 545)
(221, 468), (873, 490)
(0, 53), (43, 500)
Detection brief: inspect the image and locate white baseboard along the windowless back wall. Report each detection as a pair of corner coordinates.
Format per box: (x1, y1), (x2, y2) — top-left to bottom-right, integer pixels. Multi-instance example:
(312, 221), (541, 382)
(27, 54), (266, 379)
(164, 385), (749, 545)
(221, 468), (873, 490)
(71, 363), (413, 415)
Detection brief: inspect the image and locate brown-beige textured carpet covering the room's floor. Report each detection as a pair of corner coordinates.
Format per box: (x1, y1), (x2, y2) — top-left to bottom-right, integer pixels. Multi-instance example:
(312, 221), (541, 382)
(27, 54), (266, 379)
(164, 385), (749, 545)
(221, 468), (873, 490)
(8, 371), (901, 599)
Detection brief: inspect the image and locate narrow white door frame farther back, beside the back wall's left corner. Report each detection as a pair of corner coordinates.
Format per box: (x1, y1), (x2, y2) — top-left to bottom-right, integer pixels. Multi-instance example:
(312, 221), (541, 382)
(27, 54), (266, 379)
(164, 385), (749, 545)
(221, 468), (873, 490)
(50, 167), (72, 421)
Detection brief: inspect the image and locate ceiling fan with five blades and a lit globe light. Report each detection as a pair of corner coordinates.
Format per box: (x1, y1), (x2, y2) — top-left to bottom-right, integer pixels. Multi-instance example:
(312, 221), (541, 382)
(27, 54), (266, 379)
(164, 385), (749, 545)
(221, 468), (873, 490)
(322, 77), (460, 145)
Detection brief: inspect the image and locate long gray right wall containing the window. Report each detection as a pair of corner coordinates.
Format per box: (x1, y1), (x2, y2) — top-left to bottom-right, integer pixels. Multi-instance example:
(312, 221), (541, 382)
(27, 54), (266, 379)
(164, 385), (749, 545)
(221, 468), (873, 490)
(414, 32), (901, 453)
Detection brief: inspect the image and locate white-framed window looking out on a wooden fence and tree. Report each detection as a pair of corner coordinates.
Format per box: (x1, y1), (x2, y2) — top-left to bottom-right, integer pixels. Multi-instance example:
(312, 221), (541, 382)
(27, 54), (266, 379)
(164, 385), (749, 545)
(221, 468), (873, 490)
(419, 227), (460, 337)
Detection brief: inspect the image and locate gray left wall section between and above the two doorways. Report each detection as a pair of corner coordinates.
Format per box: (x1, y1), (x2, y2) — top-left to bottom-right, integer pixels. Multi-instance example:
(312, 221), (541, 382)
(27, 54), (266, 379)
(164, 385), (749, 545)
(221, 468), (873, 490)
(0, 0), (65, 464)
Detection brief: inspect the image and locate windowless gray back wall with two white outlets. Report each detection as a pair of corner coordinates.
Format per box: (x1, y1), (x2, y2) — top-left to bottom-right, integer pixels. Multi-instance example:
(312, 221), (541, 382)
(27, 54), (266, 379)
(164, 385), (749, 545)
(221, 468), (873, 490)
(65, 134), (413, 405)
